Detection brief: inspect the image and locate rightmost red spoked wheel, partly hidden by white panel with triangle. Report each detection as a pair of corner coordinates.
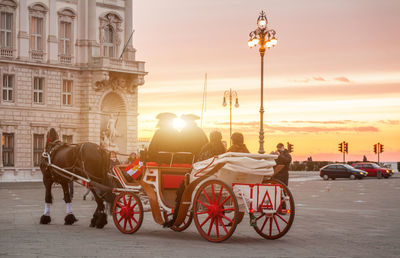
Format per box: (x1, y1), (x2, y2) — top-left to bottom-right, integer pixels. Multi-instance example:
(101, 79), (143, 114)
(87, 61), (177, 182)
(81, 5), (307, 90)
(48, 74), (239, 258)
(254, 179), (295, 239)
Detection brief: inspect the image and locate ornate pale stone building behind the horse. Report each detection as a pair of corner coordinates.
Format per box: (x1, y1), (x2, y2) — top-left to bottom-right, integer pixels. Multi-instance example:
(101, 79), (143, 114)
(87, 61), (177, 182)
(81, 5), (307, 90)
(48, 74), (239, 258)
(0, 0), (146, 181)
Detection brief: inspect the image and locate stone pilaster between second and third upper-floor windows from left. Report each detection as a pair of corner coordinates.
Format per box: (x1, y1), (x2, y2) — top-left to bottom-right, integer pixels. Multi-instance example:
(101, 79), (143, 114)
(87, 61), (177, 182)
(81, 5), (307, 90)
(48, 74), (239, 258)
(47, 0), (58, 63)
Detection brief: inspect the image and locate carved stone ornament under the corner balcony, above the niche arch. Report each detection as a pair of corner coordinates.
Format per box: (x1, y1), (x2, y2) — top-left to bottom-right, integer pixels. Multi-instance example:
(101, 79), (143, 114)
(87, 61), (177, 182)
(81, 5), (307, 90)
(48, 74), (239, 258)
(93, 75), (138, 94)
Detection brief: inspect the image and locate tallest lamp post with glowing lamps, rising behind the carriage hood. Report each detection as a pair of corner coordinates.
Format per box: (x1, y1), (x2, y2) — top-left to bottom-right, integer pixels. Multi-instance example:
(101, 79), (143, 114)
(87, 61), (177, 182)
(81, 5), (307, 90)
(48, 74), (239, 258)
(248, 11), (278, 154)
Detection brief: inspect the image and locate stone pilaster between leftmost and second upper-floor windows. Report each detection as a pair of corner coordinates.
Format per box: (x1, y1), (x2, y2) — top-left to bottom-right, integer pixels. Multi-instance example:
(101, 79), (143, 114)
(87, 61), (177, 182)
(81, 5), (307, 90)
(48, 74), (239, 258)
(17, 0), (29, 60)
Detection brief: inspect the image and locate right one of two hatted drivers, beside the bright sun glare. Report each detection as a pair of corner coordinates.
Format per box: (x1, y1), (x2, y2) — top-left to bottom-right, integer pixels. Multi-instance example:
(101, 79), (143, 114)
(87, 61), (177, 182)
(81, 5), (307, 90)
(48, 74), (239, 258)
(180, 114), (208, 163)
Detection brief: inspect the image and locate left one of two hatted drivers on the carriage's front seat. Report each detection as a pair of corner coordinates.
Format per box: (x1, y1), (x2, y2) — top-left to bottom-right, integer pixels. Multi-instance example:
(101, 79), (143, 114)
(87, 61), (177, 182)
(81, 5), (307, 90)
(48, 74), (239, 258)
(148, 113), (181, 164)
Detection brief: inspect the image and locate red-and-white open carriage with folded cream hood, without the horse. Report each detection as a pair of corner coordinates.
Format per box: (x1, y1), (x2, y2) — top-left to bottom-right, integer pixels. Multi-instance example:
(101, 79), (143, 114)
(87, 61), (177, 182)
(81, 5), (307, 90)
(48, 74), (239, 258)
(109, 153), (295, 242)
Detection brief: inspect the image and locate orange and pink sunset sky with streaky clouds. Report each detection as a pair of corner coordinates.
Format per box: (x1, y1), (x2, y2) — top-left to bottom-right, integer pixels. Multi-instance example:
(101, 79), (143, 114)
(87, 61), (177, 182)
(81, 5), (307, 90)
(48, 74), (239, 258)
(134, 0), (400, 161)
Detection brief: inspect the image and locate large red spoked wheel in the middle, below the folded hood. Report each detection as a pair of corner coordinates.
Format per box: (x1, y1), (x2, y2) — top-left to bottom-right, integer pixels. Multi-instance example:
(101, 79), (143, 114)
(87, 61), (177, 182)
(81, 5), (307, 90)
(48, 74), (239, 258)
(193, 180), (239, 242)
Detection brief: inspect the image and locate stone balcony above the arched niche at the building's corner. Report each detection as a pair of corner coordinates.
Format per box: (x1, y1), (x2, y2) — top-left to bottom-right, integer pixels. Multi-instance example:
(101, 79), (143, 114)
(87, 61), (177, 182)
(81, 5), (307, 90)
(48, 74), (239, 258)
(90, 57), (145, 74)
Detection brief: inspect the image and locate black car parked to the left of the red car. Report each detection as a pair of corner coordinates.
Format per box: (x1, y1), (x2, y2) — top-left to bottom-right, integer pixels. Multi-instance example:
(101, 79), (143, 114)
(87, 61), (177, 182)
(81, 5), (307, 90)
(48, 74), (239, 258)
(319, 164), (368, 180)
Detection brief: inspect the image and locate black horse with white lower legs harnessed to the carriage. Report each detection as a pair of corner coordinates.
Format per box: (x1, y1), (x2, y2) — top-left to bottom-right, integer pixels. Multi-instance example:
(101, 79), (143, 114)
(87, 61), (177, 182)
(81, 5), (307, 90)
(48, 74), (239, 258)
(40, 128), (115, 228)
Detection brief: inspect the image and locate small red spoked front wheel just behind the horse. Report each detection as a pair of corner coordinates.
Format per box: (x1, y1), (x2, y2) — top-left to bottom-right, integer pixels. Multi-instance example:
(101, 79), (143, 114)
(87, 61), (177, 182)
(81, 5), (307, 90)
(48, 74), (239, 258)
(113, 192), (143, 234)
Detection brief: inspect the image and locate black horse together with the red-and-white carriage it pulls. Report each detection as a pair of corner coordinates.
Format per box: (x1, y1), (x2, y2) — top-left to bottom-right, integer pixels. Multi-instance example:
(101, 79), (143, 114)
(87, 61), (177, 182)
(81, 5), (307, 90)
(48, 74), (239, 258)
(40, 129), (295, 242)
